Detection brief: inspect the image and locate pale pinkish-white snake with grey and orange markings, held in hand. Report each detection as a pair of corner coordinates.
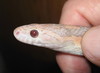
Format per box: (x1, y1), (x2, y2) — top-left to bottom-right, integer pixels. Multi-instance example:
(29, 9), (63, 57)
(13, 23), (90, 56)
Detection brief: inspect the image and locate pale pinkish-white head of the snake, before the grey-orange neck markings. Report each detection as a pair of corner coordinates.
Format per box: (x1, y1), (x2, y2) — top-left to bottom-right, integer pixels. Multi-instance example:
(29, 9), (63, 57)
(14, 24), (61, 48)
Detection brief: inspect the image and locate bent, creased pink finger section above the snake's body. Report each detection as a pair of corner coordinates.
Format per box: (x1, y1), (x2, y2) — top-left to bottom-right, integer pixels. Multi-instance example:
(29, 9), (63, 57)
(60, 0), (100, 26)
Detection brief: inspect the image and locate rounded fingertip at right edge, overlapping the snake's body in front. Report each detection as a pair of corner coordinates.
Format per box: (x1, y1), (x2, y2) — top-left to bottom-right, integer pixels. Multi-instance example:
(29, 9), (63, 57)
(82, 26), (100, 66)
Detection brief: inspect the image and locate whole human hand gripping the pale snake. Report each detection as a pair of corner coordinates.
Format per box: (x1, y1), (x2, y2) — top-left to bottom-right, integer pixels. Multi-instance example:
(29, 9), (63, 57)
(56, 0), (100, 73)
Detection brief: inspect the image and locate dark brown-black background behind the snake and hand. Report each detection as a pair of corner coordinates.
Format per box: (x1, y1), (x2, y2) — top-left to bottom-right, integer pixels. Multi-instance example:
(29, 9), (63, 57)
(0, 0), (99, 73)
